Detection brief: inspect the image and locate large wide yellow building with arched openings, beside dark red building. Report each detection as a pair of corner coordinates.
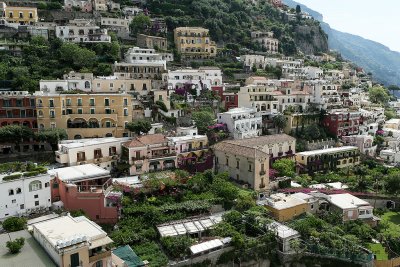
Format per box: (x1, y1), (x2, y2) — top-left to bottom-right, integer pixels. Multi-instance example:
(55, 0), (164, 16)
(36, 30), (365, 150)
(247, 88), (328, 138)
(36, 92), (133, 139)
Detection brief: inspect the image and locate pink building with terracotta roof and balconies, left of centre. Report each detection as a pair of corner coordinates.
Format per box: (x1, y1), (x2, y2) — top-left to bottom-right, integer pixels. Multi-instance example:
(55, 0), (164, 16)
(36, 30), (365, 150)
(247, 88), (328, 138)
(122, 134), (177, 175)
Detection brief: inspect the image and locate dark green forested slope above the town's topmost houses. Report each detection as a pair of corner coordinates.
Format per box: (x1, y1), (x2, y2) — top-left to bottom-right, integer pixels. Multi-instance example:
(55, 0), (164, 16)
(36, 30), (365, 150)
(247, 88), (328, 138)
(147, 0), (328, 55)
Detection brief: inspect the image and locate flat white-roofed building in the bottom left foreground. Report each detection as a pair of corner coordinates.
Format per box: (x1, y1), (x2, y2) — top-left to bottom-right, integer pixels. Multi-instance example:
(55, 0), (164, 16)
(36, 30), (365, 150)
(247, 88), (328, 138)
(32, 214), (113, 266)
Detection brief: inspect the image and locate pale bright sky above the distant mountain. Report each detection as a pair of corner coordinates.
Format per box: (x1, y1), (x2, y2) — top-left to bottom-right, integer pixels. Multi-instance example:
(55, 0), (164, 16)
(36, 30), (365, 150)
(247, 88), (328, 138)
(295, 0), (400, 52)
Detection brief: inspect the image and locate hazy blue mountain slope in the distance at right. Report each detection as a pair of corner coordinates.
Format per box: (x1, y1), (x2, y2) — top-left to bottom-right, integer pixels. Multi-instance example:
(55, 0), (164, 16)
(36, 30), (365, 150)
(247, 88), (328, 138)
(284, 0), (400, 85)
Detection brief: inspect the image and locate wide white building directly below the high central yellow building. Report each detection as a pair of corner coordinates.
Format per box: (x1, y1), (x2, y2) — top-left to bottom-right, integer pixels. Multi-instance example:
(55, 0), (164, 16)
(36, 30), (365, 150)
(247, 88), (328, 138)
(164, 67), (222, 94)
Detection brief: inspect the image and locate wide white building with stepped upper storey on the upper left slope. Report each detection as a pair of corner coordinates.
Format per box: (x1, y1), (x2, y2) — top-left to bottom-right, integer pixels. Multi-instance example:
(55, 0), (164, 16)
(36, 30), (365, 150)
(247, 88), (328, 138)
(55, 19), (111, 43)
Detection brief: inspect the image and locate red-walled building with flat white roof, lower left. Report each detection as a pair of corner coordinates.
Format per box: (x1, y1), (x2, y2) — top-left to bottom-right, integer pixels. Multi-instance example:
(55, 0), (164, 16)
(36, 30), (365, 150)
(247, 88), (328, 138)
(49, 164), (121, 223)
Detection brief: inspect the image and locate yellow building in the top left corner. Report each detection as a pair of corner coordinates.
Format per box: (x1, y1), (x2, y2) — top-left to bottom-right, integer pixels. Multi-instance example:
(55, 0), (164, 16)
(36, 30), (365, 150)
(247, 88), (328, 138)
(0, 2), (38, 25)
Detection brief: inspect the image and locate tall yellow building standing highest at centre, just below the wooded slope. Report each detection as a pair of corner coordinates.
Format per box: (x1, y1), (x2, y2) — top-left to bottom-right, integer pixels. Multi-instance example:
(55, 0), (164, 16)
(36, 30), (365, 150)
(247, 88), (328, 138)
(174, 27), (217, 59)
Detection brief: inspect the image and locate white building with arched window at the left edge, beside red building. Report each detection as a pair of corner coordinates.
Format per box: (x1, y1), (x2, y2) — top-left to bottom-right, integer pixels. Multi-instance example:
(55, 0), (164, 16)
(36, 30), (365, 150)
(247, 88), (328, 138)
(0, 173), (51, 220)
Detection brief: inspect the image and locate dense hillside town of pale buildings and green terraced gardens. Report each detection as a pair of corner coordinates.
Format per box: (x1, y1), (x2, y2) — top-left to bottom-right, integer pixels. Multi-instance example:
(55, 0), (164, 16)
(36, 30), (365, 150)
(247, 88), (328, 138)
(0, 0), (400, 267)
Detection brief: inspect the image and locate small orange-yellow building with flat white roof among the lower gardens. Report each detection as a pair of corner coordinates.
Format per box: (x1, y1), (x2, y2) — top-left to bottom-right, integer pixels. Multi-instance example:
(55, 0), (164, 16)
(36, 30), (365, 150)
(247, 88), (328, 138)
(264, 193), (310, 222)
